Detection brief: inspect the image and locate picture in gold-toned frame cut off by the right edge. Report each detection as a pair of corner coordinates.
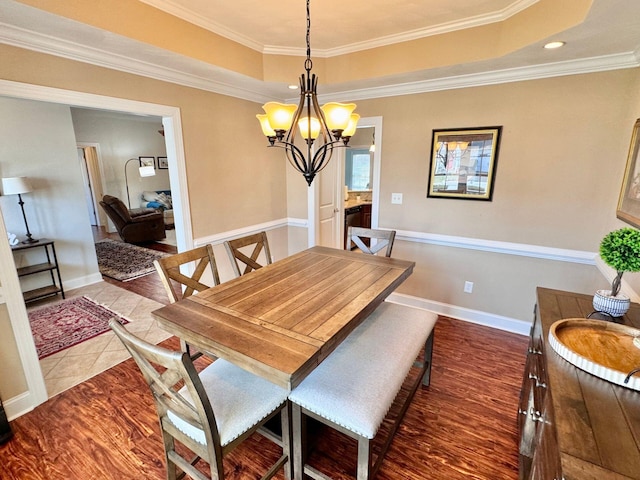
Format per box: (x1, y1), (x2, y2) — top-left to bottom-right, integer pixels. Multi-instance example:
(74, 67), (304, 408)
(616, 118), (640, 228)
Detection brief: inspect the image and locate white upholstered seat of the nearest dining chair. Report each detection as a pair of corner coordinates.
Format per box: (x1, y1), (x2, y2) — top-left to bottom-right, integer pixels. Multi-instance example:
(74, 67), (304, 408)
(167, 359), (287, 446)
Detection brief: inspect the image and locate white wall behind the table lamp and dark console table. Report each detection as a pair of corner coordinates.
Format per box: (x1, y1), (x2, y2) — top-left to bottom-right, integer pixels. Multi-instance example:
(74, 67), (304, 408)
(0, 97), (100, 288)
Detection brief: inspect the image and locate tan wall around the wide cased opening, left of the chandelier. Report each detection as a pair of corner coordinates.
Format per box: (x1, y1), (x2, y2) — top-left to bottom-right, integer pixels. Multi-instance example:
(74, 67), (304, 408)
(0, 45), (287, 237)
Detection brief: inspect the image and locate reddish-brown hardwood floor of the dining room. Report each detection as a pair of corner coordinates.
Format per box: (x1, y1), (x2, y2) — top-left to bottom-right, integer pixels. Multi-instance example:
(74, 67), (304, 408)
(0, 308), (527, 480)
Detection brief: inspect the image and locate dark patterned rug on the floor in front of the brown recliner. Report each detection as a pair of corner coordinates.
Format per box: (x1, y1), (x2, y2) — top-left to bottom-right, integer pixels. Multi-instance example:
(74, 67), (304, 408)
(95, 239), (167, 282)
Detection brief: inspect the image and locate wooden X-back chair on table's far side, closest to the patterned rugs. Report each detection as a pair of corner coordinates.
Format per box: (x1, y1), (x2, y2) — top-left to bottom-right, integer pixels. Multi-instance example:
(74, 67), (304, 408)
(153, 244), (220, 360)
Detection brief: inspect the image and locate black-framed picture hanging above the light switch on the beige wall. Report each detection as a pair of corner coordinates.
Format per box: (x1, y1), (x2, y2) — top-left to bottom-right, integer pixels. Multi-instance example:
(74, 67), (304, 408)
(427, 126), (502, 201)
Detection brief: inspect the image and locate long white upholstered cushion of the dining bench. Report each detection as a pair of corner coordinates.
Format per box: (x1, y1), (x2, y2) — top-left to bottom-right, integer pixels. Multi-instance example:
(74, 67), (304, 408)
(289, 302), (437, 439)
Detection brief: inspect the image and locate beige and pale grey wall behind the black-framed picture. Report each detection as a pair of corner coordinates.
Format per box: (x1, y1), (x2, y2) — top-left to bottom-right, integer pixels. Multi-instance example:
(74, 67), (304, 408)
(350, 69), (640, 321)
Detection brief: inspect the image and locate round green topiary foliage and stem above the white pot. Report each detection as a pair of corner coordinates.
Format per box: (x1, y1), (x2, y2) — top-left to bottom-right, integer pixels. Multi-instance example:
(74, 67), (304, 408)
(600, 227), (640, 297)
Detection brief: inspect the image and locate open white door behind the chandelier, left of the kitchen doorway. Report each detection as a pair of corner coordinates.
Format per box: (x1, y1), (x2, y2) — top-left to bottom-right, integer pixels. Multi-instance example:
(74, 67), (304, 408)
(316, 148), (344, 248)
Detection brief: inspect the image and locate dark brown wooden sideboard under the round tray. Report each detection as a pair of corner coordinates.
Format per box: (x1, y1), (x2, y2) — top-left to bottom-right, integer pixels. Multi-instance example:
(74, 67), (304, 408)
(518, 287), (640, 480)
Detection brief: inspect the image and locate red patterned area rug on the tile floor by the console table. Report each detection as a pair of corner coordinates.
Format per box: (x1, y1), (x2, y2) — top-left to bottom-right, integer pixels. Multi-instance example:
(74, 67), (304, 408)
(29, 297), (129, 359)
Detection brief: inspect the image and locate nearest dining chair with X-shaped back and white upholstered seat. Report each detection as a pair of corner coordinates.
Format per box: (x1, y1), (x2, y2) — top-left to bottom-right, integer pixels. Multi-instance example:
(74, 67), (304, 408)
(109, 319), (291, 480)
